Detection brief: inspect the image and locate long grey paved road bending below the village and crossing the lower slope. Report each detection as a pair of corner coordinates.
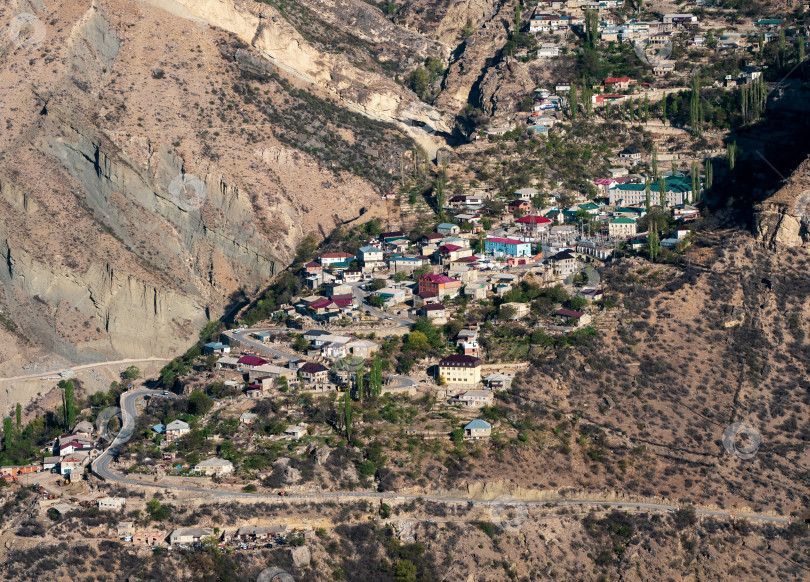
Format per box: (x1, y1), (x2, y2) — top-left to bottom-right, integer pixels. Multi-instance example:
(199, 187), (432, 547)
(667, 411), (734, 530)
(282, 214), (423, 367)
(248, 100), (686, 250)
(91, 388), (791, 525)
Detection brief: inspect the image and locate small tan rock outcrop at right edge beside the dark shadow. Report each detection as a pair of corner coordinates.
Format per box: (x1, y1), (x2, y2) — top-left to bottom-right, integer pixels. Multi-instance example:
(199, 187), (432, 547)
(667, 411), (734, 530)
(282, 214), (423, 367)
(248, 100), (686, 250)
(754, 159), (810, 249)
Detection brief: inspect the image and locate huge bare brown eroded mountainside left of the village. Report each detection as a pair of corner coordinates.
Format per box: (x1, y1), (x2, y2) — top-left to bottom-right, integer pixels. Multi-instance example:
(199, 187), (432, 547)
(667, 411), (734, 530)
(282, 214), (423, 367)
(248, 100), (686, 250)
(0, 0), (392, 364)
